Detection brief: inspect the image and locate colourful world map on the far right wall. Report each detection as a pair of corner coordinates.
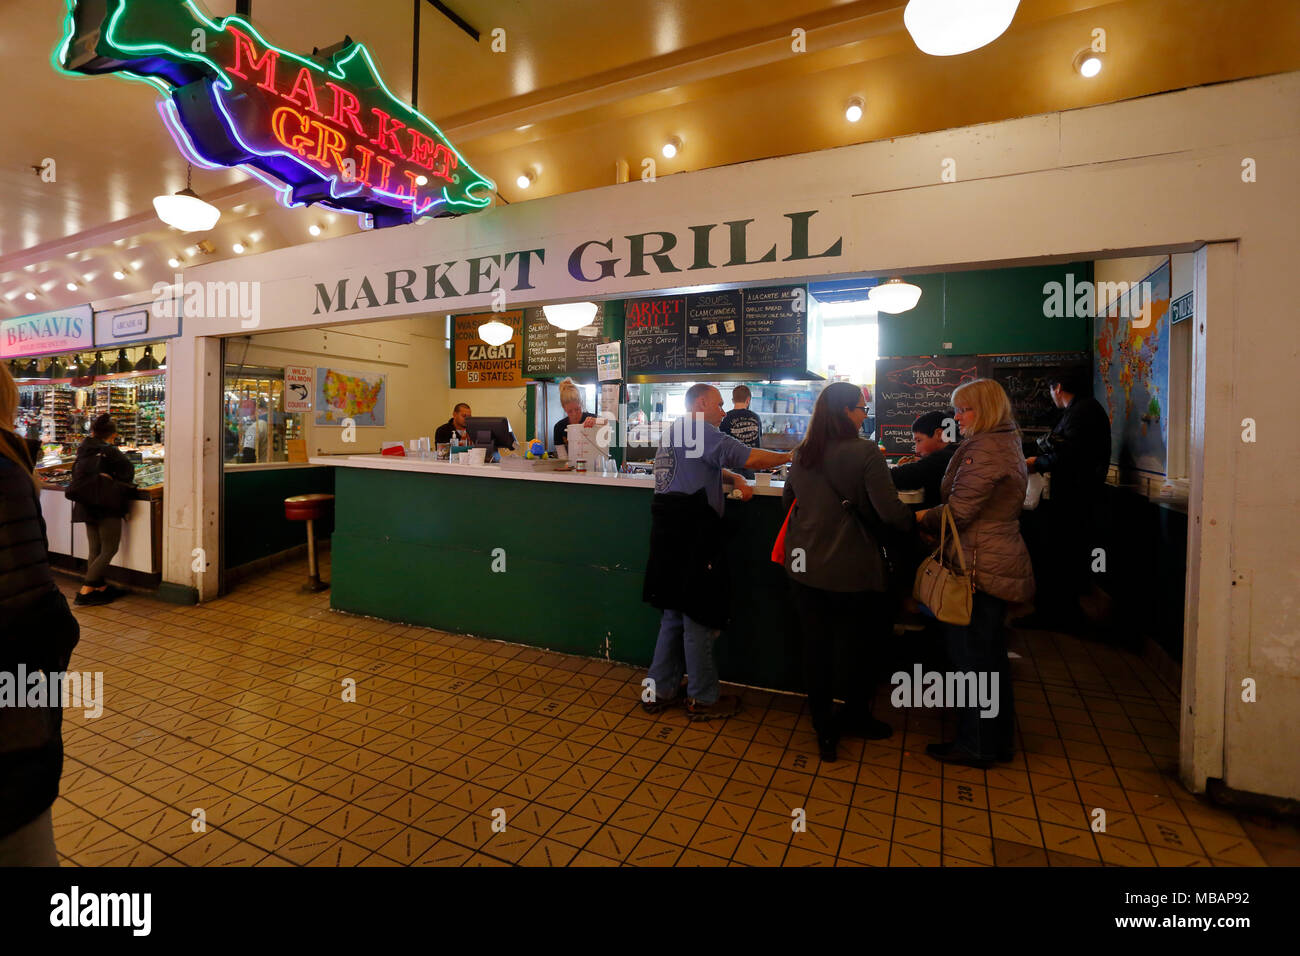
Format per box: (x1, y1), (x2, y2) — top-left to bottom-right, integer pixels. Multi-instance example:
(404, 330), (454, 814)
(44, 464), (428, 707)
(1093, 259), (1170, 475)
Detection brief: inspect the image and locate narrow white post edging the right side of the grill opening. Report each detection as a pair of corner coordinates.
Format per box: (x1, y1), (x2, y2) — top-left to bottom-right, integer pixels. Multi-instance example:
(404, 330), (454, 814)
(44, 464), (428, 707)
(1179, 242), (1240, 792)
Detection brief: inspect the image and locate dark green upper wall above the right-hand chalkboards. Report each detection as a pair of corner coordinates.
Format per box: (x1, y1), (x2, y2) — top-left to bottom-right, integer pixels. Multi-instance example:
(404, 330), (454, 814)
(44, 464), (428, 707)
(879, 261), (1092, 356)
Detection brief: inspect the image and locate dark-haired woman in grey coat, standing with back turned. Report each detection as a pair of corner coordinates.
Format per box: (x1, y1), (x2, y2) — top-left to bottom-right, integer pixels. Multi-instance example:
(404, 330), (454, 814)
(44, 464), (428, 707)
(783, 382), (913, 762)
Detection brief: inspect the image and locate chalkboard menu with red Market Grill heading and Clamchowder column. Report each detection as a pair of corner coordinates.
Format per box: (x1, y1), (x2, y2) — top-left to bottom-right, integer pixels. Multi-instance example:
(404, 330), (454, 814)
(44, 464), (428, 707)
(623, 285), (807, 376)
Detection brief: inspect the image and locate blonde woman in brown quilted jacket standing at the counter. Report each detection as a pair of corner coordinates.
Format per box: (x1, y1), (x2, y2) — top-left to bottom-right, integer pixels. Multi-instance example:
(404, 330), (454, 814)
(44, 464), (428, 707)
(917, 378), (1034, 766)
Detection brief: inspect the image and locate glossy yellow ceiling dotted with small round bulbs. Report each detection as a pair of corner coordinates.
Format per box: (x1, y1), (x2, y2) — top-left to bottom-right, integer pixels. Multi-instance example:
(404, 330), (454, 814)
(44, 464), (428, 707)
(0, 0), (1300, 319)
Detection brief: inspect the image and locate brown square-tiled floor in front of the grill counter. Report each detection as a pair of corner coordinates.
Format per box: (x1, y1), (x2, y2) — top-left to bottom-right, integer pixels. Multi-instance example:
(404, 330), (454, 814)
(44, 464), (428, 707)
(45, 556), (1300, 866)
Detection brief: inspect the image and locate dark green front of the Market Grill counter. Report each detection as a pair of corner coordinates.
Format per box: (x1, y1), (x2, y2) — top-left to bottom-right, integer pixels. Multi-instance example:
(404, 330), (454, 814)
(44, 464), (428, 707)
(313, 458), (802, 691)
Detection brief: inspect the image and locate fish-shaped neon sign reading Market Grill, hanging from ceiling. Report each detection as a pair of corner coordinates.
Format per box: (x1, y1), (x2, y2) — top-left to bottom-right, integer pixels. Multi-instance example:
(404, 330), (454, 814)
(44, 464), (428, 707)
(56, 0), (495, 226)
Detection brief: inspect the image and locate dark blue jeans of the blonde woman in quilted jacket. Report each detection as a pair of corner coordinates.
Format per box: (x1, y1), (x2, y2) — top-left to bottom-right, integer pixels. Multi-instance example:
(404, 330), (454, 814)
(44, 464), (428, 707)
(946, 591), (1015, 760)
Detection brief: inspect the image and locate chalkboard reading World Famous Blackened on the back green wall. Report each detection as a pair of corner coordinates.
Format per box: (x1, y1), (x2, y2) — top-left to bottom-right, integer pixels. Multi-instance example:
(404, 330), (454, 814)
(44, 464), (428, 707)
(875, 355), (979, 454)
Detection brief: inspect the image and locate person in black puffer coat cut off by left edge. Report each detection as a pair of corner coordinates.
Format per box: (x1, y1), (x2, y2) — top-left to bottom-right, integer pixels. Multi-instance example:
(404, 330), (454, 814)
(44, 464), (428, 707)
(0, 365), (81, 866)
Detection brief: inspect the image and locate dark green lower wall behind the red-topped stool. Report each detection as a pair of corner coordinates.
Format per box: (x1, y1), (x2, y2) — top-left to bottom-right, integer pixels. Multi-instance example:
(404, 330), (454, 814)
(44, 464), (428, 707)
(221, 467), (334, 567)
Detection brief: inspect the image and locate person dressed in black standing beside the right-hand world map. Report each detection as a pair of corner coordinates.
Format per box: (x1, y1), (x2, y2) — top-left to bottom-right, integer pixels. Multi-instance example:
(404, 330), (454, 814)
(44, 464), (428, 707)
(1014, 372), (1110, 633)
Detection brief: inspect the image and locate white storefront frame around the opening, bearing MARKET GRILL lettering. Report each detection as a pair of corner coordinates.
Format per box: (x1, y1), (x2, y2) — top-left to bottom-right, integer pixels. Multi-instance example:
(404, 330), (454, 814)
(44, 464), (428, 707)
(166, 73), (1300, 799)
